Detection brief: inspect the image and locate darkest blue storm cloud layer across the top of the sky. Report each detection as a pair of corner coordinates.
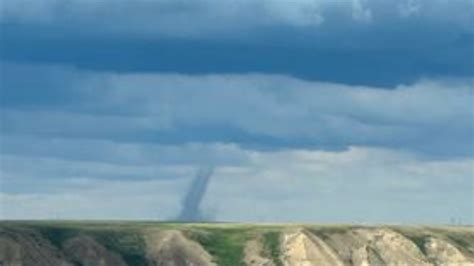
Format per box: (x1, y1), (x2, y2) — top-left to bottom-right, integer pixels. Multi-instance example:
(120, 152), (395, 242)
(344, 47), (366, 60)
(0, 0), (474, 87)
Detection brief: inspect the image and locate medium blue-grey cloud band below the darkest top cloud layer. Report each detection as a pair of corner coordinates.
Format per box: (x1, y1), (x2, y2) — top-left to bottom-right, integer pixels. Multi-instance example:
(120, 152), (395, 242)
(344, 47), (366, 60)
(0, 64), (473, 157)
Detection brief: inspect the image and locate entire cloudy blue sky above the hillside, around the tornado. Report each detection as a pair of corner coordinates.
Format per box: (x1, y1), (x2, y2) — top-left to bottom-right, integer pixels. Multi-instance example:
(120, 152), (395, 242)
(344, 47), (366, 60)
(0, 0), (474, 224)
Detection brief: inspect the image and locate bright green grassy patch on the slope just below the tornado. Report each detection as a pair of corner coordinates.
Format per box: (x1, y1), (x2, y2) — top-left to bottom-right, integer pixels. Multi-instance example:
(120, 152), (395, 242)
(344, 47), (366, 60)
(190, 228), (247, 266)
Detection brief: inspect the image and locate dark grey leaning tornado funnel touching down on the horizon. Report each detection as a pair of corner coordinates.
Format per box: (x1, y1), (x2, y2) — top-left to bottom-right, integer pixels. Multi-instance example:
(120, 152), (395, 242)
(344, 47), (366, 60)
(178, 167), (214, 222)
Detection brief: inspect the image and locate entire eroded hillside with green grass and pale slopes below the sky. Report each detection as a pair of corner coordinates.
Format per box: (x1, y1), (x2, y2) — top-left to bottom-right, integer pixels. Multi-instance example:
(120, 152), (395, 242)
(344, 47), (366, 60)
(0, 222), (474, 266)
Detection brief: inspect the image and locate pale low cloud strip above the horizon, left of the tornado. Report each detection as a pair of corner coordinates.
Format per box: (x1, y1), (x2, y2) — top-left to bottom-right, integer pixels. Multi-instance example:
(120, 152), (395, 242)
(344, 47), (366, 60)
(0, 179), (186, 220)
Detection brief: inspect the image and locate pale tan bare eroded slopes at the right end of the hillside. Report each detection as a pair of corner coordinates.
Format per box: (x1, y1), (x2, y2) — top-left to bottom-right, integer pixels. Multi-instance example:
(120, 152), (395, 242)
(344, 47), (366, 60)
(282, 228), (474, 266)
